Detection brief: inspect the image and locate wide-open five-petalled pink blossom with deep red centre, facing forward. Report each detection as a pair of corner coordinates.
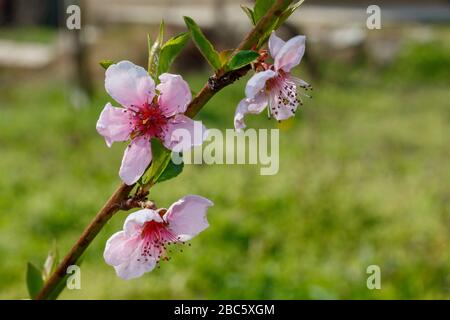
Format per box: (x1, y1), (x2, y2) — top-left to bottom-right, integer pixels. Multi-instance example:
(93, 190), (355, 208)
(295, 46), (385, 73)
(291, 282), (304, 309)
(97, 61), (206, 185)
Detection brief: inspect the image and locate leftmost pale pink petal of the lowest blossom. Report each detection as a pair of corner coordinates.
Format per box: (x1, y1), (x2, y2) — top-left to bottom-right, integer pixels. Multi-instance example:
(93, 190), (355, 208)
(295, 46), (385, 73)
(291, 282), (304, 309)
(103, 231), (139, 266)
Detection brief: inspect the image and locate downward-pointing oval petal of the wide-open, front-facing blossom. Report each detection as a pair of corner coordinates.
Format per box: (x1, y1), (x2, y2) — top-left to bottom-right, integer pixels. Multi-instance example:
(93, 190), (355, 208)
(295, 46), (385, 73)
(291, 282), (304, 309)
(119, 136), (152, 185)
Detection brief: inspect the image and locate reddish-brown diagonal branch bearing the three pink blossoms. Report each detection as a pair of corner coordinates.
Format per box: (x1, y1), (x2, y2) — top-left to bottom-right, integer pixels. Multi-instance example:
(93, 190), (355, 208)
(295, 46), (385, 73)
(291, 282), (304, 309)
(36, 0), (293, 300)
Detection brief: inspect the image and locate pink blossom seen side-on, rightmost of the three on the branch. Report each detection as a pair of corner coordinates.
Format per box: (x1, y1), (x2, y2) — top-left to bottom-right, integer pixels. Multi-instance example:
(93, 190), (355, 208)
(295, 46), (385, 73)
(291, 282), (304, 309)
(234, 32), (310, 131)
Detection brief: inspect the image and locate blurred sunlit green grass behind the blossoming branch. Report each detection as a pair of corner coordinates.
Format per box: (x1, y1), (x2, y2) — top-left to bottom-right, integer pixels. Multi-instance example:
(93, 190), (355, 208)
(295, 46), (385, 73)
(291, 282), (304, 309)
(0, 40), (450, 299)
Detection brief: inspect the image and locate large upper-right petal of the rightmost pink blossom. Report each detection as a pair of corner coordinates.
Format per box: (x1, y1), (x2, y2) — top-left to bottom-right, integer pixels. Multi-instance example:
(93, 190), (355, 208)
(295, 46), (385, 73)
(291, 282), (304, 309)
(274, 36), (306, 72)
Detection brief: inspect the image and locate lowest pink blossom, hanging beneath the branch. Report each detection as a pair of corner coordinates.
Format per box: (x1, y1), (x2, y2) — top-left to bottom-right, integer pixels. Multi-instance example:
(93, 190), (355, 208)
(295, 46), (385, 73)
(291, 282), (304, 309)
(103, 195), (213, 279)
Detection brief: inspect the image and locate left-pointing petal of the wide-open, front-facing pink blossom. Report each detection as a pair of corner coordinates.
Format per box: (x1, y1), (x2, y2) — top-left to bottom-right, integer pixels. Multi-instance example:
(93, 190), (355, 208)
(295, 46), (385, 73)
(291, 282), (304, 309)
(97, 103), (132, 147)
